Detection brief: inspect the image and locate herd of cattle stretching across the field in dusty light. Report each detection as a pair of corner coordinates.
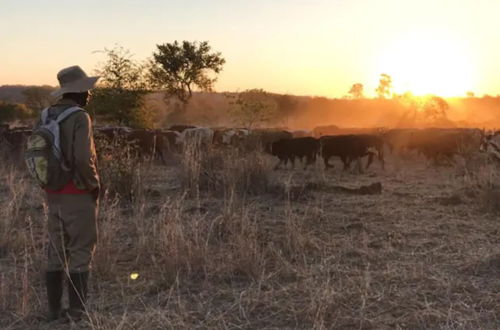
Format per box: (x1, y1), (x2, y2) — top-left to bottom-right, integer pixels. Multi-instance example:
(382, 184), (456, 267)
(0, 125), (500, 172)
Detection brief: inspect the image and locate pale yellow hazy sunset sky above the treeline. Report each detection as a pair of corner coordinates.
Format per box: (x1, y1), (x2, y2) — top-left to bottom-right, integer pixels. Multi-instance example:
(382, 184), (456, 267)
(0, 0), (500, 97)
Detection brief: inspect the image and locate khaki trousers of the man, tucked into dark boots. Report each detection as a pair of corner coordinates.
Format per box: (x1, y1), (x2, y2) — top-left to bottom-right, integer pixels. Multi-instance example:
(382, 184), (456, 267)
(47, 194), (98, 273)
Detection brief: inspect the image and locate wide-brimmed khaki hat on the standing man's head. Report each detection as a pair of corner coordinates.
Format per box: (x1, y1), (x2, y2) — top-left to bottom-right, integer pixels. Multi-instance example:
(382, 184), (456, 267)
(51, 65), (100, 96)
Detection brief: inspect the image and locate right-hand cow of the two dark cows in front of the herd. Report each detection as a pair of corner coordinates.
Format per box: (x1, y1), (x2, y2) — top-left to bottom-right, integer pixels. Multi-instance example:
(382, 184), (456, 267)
(319, 135), (384, 172)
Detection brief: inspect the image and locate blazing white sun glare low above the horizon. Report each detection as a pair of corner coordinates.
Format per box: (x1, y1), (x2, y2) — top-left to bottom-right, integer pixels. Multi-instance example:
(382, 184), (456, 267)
(377, 33), (475, 97)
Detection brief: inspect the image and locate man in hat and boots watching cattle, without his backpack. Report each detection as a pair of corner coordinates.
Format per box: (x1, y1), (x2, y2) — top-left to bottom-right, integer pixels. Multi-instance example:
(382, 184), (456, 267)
(46, 66), (100, 321)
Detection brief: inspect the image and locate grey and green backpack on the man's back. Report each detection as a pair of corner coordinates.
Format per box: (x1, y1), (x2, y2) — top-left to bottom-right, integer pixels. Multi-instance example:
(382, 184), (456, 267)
(24, 106), (83, 190)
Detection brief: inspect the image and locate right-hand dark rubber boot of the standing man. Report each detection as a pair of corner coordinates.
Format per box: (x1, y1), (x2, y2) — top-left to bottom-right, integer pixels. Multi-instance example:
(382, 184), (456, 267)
(68, 272), (89, 321)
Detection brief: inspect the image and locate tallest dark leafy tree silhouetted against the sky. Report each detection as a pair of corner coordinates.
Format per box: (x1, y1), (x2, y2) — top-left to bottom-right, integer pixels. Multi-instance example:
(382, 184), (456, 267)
(150, 41), (226, 108)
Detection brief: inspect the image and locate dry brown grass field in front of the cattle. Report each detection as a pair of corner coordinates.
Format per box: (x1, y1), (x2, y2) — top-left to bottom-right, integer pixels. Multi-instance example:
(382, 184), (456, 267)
(0, 145), (500, 329)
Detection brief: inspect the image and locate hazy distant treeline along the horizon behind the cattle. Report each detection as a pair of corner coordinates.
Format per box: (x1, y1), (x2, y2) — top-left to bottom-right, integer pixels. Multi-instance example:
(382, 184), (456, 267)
(0, 85), (500, 129)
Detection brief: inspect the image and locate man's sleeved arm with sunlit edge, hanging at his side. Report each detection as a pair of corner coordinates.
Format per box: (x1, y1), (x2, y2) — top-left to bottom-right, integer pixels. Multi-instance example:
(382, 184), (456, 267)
(73, 112), (99, 191)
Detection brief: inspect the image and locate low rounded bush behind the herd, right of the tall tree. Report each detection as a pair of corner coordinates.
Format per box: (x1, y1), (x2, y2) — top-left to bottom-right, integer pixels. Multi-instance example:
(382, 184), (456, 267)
(228, 89), (278, 129)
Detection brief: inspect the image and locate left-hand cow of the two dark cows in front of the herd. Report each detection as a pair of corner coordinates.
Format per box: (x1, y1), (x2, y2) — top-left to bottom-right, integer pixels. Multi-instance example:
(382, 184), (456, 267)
(270, 137), (319, 169)
